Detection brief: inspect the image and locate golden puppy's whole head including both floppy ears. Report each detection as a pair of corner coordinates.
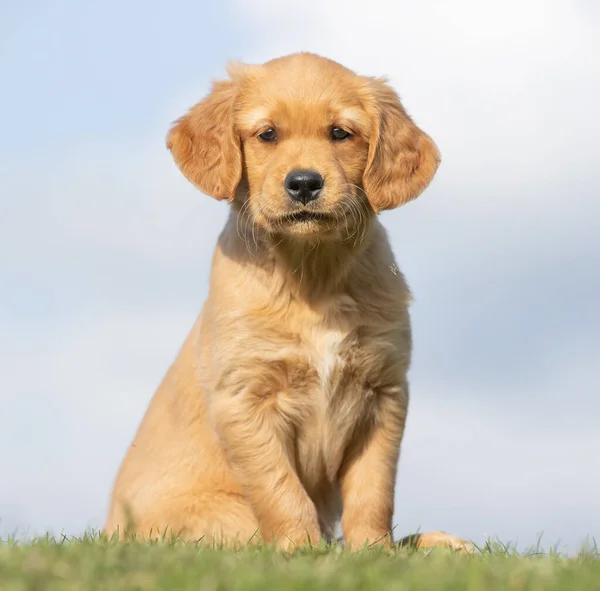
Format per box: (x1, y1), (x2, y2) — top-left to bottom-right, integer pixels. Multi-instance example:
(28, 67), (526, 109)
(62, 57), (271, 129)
(167, 53), (440, 239)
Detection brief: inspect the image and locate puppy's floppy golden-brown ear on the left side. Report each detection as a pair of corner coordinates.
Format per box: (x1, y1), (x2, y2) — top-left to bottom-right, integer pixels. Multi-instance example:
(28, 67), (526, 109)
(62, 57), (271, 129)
(167, 80), (242, 200)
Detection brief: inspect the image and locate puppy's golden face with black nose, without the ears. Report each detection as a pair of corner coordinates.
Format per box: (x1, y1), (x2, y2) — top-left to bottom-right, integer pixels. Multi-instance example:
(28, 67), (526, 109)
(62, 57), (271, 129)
(234, 59), (372, 242)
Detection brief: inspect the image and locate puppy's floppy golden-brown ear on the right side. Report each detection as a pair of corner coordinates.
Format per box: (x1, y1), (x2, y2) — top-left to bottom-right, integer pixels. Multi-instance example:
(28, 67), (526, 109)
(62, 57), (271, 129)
(363, 79), (440, 213)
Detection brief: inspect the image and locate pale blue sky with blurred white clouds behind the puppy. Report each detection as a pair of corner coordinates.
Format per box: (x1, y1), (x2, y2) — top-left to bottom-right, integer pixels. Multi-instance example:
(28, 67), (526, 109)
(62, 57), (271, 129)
(0, 0), (600, 550)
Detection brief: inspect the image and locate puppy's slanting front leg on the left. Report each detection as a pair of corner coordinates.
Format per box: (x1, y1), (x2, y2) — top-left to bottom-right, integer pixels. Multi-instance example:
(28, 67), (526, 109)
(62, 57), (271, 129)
(211, 370), (321, 550)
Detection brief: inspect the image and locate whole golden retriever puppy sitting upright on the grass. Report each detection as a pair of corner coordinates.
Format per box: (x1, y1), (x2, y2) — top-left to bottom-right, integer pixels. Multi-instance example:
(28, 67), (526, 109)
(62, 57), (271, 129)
(105, 53), (474, 549)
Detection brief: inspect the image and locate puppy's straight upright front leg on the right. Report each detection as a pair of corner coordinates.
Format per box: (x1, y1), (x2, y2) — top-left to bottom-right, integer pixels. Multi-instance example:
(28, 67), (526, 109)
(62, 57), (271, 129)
(340, 386), (408, 550)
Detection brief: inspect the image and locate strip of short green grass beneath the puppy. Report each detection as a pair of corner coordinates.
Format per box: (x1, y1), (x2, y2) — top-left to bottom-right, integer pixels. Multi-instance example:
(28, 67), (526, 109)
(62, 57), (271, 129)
(0, 535), (600, 591)
